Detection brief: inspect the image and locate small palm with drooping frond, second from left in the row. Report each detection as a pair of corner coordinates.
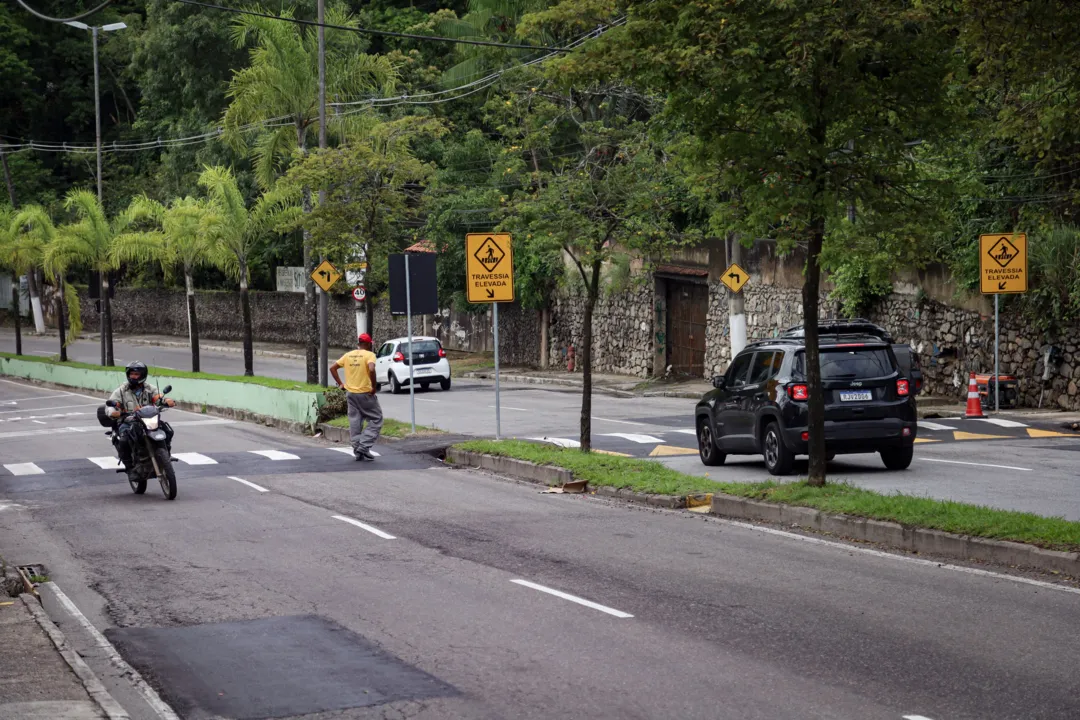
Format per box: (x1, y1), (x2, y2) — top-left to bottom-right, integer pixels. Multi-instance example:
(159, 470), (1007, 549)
(12, 205), (82, 362)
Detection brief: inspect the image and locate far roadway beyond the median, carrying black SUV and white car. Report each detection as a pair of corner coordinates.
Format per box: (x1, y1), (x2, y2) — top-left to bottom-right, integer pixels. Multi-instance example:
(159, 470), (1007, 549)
(6, 332), (1080, 520)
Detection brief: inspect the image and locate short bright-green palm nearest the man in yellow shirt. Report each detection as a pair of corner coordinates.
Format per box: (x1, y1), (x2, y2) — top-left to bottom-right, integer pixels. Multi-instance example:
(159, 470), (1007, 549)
(199, 166), (302, 376)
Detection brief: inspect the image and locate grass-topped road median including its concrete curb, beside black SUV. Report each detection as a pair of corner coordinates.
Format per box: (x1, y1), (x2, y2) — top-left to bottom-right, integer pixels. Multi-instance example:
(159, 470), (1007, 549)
(446, 440), (1080, 579)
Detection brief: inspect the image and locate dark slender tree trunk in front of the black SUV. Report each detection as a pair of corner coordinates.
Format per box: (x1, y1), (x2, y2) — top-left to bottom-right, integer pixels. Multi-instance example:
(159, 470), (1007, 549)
(802, 218), (825, 487)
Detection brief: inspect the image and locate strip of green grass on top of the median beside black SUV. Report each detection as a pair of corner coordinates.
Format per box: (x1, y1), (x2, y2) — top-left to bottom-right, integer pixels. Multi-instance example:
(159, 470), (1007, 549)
(457, 440), (1080, 552)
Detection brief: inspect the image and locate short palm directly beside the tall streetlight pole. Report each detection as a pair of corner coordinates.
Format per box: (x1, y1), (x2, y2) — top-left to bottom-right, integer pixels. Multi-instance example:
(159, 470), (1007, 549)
(45, 190), (131, 366)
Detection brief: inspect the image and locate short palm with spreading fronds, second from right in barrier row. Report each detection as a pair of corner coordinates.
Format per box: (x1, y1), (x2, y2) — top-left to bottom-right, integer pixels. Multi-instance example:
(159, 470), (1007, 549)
(111, 195), (214, 372)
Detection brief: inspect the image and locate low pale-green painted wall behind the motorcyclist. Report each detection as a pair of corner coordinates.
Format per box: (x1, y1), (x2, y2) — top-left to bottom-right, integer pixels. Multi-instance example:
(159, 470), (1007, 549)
(0, 357), (325, 427)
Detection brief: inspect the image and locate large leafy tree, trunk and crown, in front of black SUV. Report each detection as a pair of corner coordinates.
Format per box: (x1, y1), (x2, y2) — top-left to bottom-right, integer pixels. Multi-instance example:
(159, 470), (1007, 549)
(535, 0), (964, 485)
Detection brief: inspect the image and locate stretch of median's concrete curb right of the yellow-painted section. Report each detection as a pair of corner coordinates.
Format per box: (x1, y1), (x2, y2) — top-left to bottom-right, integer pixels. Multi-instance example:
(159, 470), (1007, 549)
(710, 493), (1080, 578)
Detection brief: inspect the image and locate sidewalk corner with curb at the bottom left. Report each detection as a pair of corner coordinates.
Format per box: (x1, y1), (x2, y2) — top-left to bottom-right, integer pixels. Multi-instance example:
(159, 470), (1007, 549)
(0, 594), (129, 720)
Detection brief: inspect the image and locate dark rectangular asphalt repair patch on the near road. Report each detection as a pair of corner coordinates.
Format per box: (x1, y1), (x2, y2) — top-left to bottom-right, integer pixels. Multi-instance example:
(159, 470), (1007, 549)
(106, 615), (457, 720)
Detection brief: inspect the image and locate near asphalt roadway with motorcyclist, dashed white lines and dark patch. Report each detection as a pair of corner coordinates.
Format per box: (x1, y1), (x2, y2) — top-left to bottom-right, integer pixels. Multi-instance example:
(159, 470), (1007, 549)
(0, 381), (1080, 720)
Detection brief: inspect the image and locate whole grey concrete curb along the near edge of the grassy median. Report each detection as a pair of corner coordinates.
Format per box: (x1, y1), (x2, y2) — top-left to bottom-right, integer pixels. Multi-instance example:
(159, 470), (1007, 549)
(446, 448), (1080, 578)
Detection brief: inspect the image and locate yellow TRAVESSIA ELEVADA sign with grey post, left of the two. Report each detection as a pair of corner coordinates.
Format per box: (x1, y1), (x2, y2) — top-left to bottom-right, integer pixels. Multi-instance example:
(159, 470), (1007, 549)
(465, 233), (514, 440)
